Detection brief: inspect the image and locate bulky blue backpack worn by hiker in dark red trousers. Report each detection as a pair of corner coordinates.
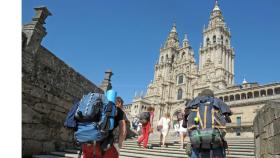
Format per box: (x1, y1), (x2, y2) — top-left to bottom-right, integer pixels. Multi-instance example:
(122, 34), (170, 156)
(74, 92), (116, 143)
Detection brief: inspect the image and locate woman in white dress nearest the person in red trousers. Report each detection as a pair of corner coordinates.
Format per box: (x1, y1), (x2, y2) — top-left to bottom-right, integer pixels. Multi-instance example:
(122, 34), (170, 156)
(158, 113), (170, 147)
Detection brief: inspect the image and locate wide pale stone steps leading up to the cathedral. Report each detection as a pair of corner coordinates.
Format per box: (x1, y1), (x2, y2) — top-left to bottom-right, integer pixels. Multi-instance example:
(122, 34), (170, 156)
(33, 135), (255, 158)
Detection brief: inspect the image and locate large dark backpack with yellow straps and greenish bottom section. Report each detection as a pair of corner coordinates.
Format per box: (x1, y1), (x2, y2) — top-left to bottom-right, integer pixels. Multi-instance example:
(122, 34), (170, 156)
(187, 97), (229, 149)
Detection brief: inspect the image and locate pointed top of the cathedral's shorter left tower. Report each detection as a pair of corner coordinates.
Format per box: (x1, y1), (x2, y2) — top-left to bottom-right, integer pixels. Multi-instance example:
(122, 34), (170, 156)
(164, 23), (179, 48)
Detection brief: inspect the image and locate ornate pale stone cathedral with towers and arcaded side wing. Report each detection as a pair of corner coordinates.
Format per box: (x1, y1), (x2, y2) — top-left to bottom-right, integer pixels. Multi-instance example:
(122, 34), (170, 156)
(127, 1), (280, 136)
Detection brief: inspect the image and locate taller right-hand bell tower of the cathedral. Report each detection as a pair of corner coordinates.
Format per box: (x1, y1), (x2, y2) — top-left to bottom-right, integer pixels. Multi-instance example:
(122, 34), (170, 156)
(199, 0), (235, 89)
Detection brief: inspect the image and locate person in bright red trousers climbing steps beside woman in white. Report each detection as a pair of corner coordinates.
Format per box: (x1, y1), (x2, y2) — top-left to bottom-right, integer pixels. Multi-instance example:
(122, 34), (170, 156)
(137, 107), (154, 149)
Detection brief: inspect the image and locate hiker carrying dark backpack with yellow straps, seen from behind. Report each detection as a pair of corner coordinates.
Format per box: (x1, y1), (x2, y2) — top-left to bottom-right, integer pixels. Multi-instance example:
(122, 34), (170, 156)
(186, 89), (232, 158)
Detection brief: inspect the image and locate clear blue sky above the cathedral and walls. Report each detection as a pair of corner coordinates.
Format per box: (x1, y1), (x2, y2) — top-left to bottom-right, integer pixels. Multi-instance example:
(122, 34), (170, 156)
(22, 0), (280, 103)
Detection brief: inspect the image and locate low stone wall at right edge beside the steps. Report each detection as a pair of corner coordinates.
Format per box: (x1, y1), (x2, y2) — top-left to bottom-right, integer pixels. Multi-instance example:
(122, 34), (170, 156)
(254, 101), (280, 158)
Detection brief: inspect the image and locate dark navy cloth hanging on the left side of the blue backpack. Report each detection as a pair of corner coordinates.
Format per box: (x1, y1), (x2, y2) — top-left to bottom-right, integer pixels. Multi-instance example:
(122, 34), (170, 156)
(64, 101), (79, 130)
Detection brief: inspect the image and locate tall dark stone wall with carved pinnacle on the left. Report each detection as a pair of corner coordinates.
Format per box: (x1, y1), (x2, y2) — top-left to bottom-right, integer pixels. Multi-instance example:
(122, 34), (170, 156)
(21, 7), (110, 157)
